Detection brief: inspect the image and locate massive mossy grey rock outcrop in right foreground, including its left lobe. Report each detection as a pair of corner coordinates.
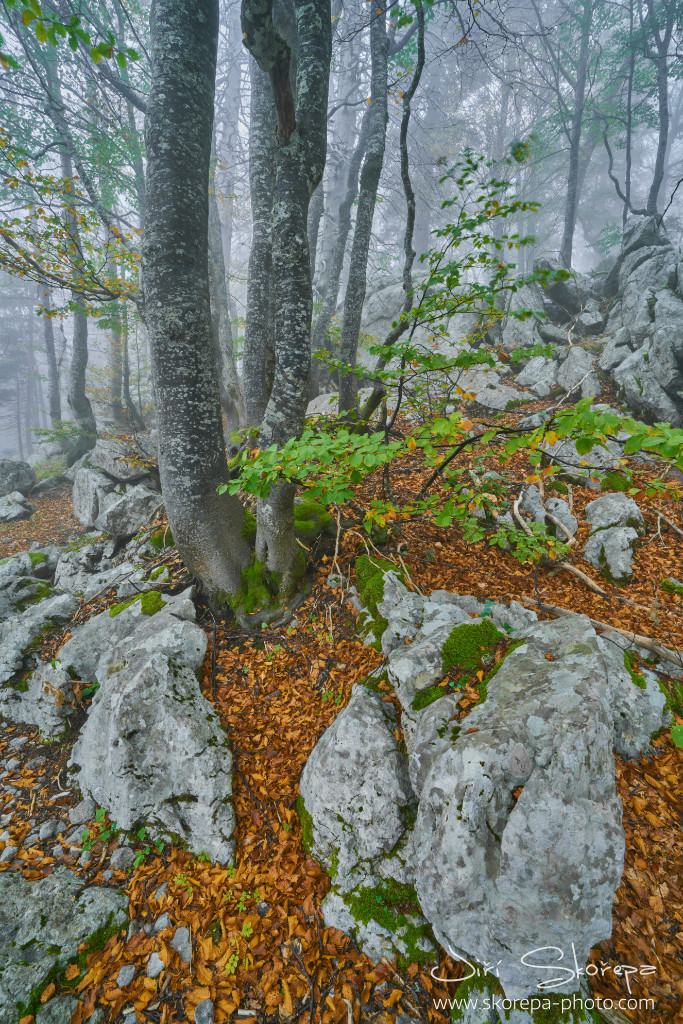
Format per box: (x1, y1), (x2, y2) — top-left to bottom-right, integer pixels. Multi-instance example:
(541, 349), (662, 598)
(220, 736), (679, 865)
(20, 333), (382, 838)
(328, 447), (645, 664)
(300, 573), (667, 998)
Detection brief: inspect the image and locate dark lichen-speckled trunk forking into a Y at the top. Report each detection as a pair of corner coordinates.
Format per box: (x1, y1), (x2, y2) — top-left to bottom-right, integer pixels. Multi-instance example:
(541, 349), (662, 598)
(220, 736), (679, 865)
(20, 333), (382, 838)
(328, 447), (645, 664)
(242, 0), (332, 594)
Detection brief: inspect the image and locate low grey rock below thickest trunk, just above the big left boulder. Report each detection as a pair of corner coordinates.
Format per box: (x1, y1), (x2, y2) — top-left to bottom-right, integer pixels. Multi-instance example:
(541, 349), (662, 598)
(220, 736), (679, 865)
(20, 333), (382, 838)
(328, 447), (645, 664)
(59, 589), (208, 686)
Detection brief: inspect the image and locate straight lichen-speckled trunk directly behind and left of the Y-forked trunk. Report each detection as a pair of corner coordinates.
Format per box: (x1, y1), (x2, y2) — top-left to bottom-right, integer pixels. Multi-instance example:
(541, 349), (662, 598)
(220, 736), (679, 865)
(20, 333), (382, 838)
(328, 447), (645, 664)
(242, 56), (275, 426)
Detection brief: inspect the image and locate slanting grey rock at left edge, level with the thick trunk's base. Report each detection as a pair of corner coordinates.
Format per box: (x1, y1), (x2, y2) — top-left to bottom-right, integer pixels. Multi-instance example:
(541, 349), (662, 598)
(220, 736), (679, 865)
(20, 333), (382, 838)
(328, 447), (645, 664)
(0, 594), (78, 684)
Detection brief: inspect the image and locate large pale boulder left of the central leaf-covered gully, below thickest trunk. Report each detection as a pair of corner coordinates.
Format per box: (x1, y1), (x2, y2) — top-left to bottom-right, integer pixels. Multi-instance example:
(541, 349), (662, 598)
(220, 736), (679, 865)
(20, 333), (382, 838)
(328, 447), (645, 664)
(71, 653), (236, 863)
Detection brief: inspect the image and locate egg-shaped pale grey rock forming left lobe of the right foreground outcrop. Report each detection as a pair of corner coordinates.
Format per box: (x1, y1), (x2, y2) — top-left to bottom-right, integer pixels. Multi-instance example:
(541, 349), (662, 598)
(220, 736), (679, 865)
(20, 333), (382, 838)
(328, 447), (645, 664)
(299, 685), (415, 889)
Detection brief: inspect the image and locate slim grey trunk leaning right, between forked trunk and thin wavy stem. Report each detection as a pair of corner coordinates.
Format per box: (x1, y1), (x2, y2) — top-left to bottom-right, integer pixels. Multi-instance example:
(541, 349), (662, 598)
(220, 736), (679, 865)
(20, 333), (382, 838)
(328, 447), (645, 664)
(339, 7), (389, 413)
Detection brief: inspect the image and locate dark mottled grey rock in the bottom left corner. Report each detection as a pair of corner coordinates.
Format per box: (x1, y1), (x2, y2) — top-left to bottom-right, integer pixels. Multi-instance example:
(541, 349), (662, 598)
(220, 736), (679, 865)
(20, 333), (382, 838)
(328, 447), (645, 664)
(0, 868), (128, 1024)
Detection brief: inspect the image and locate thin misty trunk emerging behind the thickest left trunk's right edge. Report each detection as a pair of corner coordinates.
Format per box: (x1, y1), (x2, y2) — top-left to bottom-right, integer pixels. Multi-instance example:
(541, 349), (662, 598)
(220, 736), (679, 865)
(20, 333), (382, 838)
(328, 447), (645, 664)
(209, 156), (245, 431)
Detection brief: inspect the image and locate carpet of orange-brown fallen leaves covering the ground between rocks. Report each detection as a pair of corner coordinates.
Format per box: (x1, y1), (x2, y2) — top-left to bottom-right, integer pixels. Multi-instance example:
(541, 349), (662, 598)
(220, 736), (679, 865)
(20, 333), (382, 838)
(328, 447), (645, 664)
(0, 399), (683, 1024)
